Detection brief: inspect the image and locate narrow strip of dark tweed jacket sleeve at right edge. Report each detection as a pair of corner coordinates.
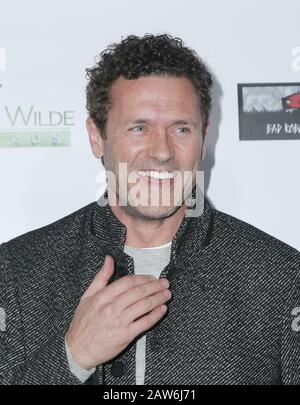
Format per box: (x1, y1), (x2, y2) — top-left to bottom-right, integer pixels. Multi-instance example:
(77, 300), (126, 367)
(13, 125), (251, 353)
(281, 266), (300, 385)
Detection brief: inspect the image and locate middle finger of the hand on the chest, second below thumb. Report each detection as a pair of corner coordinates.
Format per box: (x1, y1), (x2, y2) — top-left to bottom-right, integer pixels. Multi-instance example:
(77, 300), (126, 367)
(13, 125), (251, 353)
(114, 278), (169, 311)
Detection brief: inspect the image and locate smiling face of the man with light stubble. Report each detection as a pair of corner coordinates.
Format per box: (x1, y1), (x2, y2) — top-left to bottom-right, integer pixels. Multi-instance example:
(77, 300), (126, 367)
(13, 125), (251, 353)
(95, 76), (203, 220)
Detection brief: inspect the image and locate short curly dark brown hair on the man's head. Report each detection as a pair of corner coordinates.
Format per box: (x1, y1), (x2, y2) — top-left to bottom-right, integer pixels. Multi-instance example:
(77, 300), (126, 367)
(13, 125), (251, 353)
(86, 34), (213, 139)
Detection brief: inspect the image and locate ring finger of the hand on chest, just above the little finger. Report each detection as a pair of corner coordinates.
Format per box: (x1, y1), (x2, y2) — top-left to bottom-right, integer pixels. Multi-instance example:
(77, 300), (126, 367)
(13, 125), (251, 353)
(122, 290), (172, 324)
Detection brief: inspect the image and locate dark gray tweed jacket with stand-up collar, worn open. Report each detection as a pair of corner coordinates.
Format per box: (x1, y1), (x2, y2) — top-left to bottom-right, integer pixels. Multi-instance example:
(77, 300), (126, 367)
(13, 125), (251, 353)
(0, 191), (300, 385)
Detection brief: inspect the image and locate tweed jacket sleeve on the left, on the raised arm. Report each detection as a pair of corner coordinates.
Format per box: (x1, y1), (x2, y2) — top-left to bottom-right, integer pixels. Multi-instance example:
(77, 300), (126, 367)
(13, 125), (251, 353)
(0, 244), (81, 385)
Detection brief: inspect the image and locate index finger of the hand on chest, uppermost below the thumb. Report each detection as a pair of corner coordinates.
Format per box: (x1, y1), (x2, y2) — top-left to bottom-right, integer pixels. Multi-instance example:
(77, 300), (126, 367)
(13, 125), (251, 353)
(97, 275), (156, 302)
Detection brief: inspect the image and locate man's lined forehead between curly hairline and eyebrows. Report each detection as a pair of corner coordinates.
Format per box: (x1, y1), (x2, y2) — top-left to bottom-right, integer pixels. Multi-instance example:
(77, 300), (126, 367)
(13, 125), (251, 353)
(110, 76), (200, 119)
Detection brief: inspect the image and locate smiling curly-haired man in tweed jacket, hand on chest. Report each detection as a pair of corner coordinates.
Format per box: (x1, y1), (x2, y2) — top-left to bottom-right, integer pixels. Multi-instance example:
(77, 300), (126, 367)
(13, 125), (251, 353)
(0, 35), (300, 385)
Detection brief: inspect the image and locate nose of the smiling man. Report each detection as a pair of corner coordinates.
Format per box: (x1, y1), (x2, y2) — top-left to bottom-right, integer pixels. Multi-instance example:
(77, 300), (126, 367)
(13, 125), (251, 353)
(148, 131), (174, 162)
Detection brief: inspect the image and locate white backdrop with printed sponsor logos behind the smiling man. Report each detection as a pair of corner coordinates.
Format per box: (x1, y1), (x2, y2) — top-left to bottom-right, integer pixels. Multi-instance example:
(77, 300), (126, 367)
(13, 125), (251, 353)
(0, 0), (300, 249)
